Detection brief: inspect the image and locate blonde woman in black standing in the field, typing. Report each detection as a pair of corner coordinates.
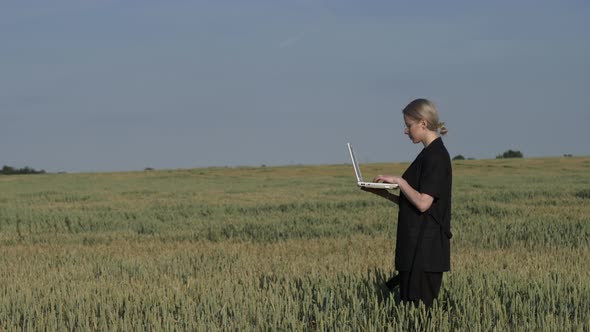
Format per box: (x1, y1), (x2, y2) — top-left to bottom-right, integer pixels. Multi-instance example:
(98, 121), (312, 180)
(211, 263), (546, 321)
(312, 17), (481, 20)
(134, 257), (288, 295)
(365, 99), (452, 307)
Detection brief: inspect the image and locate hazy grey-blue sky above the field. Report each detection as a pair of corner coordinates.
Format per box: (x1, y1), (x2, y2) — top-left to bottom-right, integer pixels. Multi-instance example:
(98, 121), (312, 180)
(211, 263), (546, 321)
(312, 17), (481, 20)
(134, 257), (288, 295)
(0, 0), (590, 172)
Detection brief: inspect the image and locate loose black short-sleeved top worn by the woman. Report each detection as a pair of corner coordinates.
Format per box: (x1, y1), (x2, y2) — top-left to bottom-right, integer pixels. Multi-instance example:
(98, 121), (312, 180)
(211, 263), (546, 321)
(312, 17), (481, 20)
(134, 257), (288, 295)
(395, 137), (453, 272)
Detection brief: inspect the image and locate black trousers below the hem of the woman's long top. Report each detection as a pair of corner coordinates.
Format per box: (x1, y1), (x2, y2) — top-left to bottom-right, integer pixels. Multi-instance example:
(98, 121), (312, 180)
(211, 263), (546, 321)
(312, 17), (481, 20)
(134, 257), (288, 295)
(399, 270), (442, 308)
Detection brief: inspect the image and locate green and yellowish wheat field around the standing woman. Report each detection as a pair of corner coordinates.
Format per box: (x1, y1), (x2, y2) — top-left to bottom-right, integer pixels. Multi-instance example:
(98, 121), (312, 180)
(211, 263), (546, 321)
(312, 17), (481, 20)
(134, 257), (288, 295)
(0, 157), (590, 331)
